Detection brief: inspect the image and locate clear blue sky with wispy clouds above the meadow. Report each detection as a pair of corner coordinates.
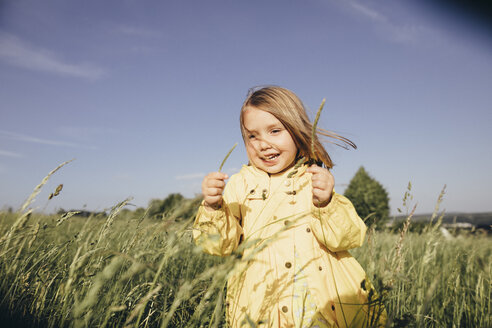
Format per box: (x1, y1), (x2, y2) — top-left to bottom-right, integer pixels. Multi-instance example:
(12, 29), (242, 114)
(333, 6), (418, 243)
(0, 0), (492, 213)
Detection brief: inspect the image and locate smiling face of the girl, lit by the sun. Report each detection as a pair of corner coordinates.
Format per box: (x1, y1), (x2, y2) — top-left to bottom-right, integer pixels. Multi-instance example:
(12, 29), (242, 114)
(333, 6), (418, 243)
(243, 108), (297, 174)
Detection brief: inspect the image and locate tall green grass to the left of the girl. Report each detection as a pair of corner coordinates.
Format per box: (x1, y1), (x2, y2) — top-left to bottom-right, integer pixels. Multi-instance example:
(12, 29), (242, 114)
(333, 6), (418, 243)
(0, 206), (227, 327)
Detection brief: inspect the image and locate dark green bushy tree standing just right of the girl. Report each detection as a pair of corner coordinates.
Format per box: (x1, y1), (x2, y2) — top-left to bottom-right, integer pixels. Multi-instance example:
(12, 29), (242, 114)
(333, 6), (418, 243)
(344, 166), (389, 228)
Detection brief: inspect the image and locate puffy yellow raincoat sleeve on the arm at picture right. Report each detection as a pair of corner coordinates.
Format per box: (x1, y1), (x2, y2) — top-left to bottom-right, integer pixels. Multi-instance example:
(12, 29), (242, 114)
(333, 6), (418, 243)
(311, 192), (367, 252)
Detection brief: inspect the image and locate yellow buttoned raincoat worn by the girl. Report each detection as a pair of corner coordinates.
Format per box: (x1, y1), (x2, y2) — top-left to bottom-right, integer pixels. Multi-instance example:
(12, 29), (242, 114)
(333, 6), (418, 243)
(193, 165), (384, 328)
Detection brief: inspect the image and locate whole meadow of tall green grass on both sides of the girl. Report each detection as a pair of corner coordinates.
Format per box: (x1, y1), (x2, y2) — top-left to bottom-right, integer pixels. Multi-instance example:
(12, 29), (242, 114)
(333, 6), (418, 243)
(0, 168), (492, 327)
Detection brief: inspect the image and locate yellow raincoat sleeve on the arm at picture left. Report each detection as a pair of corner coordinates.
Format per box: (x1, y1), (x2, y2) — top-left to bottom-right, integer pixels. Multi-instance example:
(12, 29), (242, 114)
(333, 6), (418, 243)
(193, 175), (243, 256)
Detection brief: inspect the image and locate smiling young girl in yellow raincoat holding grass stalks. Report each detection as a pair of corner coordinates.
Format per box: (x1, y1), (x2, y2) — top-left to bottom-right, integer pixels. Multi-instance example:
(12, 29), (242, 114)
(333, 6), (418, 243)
(193, 86), (384, 328)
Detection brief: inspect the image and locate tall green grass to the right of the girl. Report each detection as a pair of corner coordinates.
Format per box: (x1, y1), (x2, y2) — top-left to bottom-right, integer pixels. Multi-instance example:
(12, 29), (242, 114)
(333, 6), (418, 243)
(352, 231), (492, 327)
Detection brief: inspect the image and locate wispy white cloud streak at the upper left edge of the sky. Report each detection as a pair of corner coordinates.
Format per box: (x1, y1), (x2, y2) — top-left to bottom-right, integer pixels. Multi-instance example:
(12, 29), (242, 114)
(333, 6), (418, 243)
(0, 32), (106, 79)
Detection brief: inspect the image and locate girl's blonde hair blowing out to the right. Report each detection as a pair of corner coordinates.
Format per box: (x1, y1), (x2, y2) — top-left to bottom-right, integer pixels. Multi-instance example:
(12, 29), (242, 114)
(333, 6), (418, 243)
(239, 86), (357, 168)
